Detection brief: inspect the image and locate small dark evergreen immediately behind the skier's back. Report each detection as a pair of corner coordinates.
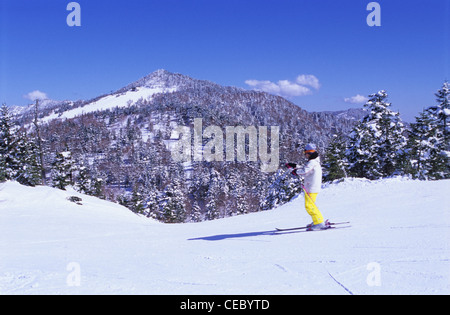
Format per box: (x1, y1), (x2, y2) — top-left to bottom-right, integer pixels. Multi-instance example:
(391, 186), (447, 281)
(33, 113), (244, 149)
(323, 135), (348, 182)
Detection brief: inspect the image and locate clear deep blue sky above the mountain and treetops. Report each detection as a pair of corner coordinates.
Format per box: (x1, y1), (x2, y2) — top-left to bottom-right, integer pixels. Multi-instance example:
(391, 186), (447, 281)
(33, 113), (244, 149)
(0, 0), (450, 121)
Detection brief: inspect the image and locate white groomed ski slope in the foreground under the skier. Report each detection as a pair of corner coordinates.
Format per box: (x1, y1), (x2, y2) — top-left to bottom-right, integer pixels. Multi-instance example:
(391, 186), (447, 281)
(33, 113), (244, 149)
(0, 179), (450, 294)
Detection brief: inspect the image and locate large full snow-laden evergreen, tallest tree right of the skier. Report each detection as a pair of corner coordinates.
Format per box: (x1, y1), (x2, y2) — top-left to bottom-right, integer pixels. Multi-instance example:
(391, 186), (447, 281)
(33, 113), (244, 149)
(347, 91), (406, 179)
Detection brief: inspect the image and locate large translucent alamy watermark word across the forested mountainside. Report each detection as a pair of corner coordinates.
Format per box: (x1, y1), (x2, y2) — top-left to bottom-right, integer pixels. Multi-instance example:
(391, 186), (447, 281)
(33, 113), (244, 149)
(170, 118), (280, 172)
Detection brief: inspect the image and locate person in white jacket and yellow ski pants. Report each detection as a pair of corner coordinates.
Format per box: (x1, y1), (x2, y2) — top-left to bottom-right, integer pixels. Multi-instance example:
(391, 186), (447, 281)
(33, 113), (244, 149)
(286, 144), (330, 231)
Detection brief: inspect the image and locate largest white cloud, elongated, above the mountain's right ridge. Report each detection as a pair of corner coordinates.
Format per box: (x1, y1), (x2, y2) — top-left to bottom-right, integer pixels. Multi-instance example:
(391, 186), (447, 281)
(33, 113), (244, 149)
(245, 74), (320, 97)
